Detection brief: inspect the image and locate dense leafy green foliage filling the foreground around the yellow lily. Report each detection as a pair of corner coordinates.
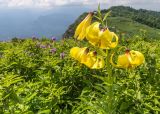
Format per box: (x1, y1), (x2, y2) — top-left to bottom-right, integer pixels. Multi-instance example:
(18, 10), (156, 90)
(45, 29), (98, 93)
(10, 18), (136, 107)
(0, 34), (160, 114)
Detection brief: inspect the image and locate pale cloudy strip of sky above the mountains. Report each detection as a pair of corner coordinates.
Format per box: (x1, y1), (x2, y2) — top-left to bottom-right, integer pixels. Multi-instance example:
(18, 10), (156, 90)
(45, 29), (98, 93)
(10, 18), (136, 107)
(0, 0), (160, 10)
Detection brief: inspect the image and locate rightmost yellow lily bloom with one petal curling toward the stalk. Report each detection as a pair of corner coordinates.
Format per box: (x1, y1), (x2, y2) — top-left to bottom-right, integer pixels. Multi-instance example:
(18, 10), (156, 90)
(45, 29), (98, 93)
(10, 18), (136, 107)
(110, 50), (145, 68)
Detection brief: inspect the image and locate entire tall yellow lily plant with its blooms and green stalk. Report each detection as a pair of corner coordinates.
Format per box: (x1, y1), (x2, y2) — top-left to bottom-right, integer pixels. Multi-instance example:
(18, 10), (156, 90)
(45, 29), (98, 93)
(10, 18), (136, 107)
(70, 6), (144, 114)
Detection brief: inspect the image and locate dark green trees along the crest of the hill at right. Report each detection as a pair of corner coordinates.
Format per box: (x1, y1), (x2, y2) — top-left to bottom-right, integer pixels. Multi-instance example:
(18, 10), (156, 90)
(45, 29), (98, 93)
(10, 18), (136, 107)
(109, 6), (160, 29)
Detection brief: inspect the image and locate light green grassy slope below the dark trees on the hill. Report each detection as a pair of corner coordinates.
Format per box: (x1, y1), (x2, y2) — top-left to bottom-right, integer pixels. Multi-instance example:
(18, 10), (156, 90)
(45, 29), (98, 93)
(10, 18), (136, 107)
(108, 17), (160, 39)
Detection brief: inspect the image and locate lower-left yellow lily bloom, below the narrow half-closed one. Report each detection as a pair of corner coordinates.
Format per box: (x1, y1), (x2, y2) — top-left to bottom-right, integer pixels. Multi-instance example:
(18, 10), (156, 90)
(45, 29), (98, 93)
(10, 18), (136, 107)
(70, 47), (105, 69)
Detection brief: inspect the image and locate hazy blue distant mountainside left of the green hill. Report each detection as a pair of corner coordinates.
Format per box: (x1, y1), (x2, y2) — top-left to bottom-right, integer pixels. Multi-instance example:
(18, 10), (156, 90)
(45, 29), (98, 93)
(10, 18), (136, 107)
(0, 6), (89, 41)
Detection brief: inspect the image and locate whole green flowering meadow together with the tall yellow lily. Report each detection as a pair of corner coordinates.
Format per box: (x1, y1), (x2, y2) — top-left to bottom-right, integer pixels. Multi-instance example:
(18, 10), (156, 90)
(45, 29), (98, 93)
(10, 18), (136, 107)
(0, 6), (160, 114)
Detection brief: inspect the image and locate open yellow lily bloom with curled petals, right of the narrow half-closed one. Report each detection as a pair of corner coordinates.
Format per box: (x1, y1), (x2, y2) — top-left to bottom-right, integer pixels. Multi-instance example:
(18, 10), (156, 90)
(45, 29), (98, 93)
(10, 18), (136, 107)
(86, 22), (118, 49)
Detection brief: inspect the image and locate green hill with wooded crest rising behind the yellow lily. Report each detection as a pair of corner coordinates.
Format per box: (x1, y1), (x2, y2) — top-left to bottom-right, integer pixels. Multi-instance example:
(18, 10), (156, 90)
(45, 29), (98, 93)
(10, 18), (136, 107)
(63, 6), (160, 39)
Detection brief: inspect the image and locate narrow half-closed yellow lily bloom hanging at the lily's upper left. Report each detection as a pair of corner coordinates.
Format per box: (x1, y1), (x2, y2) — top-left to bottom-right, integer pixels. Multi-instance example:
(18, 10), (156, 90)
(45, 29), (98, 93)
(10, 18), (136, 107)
(74, 13), (93, 40)
